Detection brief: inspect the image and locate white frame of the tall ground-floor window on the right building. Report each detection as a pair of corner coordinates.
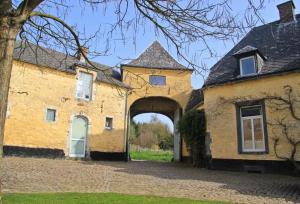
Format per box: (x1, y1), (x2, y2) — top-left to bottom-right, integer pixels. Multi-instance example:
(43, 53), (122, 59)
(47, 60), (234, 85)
(240, 105), (266, 152)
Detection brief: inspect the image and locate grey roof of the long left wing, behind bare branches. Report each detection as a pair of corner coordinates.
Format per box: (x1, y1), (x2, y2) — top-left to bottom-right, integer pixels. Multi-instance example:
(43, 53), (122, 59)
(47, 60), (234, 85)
(14, 41), (129, 88)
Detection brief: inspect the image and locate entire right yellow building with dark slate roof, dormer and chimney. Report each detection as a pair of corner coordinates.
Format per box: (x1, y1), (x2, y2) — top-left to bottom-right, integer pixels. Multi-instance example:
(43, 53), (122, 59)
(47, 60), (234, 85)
(188, 1), (300, 173)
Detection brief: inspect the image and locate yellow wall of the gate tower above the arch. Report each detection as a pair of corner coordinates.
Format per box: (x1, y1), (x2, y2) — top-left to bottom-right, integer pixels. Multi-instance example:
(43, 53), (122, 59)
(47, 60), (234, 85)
(122, 65), (192, 156)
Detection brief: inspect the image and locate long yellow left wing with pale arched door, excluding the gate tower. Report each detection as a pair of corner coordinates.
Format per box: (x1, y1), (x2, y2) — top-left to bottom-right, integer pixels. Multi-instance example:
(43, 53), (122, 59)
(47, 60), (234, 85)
(4, 42), (129, 159)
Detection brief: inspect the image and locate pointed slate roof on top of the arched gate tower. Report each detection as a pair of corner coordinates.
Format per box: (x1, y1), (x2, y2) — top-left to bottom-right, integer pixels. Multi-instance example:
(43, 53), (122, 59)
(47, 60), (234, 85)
(126, 41), (191, 70)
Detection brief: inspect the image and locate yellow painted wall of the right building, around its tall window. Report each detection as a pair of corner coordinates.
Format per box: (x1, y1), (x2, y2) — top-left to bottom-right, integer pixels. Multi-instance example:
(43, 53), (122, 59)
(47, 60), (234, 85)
(204, 73), (300, 160)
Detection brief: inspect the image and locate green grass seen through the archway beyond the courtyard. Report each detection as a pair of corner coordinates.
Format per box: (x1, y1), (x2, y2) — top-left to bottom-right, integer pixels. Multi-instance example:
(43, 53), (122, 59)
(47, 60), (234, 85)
(130, 150), (173, 162)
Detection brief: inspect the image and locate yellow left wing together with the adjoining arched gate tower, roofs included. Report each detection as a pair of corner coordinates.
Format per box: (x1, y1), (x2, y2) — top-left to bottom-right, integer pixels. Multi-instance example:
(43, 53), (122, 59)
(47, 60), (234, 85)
(4, 42), (192, 161)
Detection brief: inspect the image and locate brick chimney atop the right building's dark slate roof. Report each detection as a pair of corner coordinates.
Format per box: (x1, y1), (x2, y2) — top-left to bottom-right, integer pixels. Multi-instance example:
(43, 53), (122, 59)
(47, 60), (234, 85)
(277, 1), (295, 23)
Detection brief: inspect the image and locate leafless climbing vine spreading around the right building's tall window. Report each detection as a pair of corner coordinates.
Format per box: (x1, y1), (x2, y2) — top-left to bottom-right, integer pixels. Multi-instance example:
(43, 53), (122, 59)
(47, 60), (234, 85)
(210, 85), (300, 174)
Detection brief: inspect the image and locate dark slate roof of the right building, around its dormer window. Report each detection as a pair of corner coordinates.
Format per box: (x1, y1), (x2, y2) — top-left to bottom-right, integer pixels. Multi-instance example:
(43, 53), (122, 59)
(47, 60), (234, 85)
(204, 14), (300, 86)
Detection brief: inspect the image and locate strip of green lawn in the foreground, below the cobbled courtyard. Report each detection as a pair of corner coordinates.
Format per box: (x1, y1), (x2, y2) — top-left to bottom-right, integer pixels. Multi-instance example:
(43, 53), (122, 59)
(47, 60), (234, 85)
(3, 193), (227, 204)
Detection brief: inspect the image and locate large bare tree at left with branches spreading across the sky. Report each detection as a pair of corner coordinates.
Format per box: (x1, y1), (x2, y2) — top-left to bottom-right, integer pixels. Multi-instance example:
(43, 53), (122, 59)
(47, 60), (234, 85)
(0, 0), (264, 157)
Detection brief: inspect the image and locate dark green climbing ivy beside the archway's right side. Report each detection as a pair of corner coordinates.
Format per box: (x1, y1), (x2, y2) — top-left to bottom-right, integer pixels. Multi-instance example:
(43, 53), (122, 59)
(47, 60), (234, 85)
(178, 110), (206, 167)
